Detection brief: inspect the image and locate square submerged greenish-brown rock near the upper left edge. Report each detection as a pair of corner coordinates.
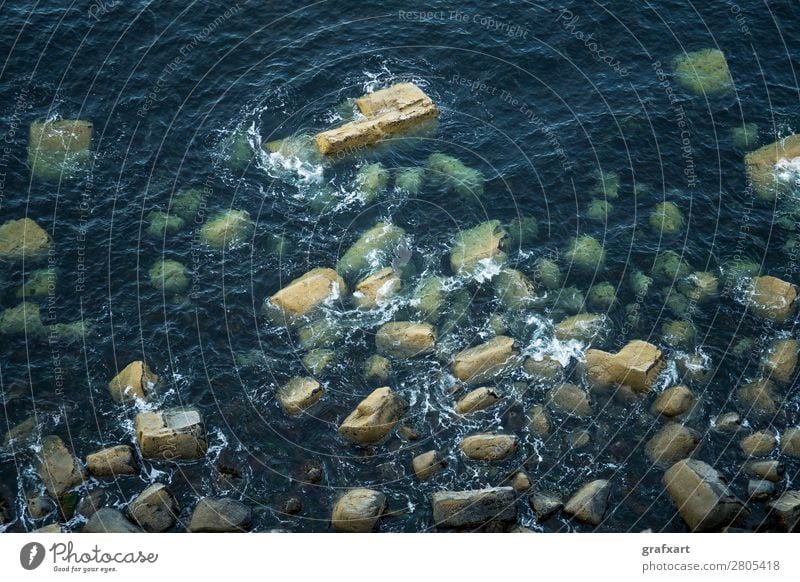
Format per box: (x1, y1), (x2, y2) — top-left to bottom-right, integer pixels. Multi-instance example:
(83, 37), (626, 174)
(28, 119), (93, 180)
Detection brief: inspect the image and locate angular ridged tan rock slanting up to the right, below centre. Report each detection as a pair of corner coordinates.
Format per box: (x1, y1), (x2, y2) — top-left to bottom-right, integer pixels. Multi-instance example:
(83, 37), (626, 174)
(339, 387), (408, 444)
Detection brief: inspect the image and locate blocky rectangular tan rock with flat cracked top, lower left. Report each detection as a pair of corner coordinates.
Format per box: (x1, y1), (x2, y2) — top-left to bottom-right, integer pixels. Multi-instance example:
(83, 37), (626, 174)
(134, 407), (208, 461)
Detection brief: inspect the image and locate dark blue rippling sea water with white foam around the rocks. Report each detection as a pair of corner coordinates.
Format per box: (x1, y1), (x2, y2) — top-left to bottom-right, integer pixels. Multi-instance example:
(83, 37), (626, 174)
(0, 0), (800, 531)
